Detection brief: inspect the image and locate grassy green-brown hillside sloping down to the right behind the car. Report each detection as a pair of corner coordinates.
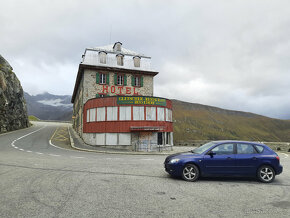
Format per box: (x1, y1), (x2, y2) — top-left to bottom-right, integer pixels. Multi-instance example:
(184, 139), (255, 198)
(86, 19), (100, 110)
(172, 100), (290, 142)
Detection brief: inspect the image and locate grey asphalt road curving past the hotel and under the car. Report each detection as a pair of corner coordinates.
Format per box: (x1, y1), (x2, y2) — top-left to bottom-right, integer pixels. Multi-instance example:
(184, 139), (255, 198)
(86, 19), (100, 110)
(0, 122), (290, 217)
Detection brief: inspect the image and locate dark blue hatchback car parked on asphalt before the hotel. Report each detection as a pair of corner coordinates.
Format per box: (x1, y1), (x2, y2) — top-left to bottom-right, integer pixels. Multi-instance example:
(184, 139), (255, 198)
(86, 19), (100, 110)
(164, 141), (283, 183)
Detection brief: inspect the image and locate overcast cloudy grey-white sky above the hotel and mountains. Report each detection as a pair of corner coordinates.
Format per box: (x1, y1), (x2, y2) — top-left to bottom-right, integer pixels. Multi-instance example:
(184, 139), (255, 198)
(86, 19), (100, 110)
(0, 0), (290, 119)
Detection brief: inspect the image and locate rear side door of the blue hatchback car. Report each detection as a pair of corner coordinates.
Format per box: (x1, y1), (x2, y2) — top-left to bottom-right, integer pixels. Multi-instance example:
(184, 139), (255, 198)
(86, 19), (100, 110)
(236, 143), (260, 175)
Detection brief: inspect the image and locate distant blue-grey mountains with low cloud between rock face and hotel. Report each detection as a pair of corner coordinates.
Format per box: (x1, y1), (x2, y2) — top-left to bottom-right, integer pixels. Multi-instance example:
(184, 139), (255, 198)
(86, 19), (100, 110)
(24, 92), (73, 121)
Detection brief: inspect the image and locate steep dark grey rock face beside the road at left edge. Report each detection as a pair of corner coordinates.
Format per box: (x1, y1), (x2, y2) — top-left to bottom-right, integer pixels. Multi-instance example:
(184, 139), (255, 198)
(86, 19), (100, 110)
(0, 55), (29, 133)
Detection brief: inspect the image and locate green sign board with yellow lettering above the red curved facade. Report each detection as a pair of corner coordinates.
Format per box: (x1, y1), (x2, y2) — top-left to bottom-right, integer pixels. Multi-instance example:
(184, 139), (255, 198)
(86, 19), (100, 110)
(117, 96), (166, 106)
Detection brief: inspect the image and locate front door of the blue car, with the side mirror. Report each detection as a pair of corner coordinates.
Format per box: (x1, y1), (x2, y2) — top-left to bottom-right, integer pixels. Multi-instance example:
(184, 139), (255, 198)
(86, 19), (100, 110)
(203, 143), (236, 175)
